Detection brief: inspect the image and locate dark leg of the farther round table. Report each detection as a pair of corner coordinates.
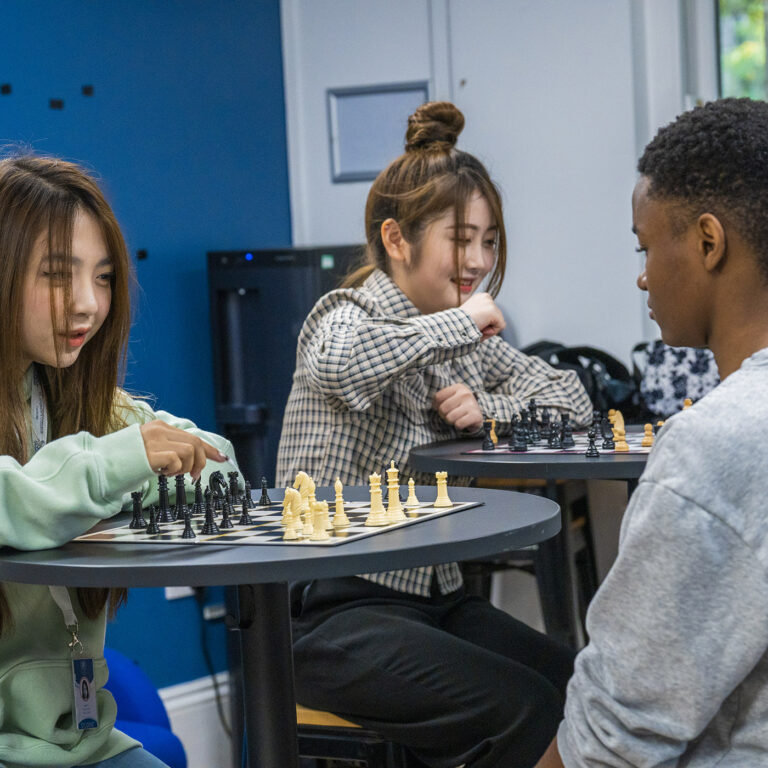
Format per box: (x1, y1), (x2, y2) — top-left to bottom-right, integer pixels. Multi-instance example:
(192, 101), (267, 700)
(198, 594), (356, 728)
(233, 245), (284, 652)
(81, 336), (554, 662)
(536, 480), (578, 648)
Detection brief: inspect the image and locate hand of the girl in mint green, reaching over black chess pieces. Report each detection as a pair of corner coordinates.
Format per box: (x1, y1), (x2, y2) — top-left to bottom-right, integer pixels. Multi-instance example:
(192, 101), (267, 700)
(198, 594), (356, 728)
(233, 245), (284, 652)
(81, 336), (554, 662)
(140, 419), (228, 480)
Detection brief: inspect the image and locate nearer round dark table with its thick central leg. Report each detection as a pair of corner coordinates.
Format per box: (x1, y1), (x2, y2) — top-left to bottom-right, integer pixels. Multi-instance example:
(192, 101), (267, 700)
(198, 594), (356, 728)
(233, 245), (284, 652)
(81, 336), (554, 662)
(0, 487), (560, 768)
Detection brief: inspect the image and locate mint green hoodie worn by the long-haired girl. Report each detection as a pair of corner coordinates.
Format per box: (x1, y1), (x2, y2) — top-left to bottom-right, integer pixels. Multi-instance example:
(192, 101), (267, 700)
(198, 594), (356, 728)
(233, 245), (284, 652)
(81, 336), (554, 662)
(0, 368), (237, 768)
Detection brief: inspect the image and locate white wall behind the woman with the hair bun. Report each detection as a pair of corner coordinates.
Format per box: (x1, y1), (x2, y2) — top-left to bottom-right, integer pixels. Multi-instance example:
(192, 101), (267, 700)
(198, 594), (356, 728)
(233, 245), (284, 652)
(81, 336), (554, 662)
(281, 0), (714, 360)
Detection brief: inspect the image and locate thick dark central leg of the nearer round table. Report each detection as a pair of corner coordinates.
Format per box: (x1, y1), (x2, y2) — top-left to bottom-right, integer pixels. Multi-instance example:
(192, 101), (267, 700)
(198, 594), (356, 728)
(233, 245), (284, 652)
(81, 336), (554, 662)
(237, 583), (299, 768)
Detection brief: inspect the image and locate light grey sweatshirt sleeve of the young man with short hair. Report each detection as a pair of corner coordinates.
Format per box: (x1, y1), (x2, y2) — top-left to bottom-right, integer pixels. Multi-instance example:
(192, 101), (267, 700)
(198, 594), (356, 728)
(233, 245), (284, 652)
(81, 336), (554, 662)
(558, 481), (768, 768)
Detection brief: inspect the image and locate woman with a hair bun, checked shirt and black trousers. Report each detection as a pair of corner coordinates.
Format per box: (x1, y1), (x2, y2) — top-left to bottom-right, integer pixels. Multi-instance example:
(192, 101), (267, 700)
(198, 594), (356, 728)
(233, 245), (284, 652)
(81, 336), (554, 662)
(277, 102), (592, 768)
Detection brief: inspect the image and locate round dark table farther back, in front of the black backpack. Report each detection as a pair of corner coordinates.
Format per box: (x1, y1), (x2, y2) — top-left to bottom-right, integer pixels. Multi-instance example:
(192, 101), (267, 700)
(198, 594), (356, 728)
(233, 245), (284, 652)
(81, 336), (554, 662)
(408, 436), (648, 646)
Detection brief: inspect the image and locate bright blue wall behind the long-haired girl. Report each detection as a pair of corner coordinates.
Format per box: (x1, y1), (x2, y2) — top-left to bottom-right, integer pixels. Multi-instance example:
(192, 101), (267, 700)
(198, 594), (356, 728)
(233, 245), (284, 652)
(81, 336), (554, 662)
(0, 0), (290, 685)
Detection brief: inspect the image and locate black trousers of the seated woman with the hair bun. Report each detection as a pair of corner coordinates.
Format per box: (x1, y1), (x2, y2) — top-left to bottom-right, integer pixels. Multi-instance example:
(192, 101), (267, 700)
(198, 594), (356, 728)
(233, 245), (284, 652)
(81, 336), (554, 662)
(293, 577), (573, 768)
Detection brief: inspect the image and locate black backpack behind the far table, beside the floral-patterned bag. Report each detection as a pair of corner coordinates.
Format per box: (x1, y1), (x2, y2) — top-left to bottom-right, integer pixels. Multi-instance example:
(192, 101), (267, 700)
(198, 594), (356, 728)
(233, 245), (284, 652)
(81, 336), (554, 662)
(521, 340), (643, 421)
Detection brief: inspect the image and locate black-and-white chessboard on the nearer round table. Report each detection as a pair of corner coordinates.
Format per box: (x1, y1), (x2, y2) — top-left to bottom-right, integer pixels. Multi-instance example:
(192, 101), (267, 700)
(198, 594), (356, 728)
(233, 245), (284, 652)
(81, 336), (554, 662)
(75, 501), (482, 547)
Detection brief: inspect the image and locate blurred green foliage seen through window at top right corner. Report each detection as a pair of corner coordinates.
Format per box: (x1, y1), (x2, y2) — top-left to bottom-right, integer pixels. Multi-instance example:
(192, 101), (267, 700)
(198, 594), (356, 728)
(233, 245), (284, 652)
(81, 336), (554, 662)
(718, 0), (768, 99)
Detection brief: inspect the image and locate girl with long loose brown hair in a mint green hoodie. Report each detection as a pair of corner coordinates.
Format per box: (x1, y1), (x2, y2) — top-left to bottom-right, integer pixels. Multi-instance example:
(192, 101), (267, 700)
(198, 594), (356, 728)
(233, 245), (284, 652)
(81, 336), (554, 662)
(0, 155), (237, 768)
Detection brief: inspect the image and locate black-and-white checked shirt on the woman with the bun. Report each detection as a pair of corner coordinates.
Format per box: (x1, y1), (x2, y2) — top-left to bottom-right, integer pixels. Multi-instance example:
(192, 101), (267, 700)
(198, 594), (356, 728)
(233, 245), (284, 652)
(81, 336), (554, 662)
(277, 270), (592, 597)
